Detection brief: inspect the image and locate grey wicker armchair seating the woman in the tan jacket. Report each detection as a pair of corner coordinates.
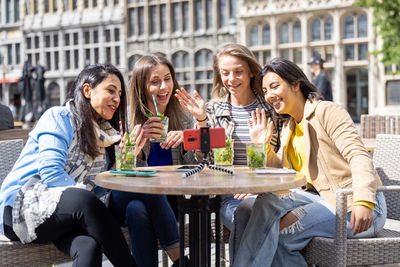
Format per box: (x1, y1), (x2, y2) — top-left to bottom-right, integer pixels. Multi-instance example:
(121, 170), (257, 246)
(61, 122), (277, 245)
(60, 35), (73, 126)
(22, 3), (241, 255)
(303, 134), (400, 266)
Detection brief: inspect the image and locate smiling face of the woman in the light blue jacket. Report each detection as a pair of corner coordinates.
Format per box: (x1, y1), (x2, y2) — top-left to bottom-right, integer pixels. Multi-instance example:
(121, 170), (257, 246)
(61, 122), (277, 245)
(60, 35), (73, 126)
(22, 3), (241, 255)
(83, 74), (122, 120)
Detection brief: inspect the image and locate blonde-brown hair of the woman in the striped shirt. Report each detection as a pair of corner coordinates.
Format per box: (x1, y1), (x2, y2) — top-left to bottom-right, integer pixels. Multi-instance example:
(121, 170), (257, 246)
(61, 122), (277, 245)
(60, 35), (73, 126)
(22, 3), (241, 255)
(211, 44), (263, 98)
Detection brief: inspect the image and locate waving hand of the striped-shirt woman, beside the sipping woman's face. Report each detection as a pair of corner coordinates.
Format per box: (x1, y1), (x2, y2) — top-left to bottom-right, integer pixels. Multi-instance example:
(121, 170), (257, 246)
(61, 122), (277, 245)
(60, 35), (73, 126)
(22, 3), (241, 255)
(175, 88), (207, 126)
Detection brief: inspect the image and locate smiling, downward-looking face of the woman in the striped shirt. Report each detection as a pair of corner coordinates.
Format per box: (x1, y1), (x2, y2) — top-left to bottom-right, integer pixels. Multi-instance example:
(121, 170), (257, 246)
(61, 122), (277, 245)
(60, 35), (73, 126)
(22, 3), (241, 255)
(218, 55), (254, 97)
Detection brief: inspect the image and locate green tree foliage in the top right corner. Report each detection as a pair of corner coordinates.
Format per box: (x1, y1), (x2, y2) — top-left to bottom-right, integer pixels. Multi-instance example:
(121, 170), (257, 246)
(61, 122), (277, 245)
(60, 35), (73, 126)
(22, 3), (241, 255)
(355, 0), (400, 70)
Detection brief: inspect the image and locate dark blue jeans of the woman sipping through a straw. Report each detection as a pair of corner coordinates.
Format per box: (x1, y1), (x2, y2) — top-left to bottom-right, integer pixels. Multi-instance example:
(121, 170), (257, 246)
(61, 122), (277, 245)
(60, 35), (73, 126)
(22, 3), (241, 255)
(109, 190), (179, 267)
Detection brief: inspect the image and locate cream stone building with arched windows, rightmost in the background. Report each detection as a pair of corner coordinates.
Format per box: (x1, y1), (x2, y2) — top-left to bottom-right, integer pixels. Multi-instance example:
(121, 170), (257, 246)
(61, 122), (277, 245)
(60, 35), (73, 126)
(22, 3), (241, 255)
(238, 0), (400, 121)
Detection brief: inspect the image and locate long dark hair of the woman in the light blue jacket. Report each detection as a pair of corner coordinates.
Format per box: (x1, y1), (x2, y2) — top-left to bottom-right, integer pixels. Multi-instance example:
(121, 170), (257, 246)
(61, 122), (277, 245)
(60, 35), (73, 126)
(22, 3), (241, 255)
(66, 64), (127, 158)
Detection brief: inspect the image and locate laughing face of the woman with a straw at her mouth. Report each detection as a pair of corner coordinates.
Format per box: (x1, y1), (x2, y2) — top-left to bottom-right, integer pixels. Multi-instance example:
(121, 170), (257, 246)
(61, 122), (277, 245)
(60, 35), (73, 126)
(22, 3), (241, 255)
(146, 64), (174, 114)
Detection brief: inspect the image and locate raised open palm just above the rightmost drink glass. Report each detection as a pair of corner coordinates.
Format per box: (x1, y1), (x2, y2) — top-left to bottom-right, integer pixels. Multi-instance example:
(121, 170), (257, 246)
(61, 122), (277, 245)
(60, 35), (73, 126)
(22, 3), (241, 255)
(247, 108), (273, 144)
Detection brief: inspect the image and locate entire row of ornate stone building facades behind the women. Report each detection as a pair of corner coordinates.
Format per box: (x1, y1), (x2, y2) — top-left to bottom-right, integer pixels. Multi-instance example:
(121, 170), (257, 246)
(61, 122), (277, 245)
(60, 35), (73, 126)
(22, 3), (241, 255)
(0, 0), (400, 121)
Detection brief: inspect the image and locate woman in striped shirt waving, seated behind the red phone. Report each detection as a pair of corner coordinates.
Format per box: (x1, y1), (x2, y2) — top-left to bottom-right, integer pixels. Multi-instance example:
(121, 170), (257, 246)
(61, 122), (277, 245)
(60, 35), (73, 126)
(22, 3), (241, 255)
(175, 44), (282, 260)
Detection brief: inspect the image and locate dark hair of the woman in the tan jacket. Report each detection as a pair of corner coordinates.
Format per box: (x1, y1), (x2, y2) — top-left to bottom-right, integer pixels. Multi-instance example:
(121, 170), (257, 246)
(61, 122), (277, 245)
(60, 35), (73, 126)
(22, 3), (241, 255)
(261, 58), (323, 100)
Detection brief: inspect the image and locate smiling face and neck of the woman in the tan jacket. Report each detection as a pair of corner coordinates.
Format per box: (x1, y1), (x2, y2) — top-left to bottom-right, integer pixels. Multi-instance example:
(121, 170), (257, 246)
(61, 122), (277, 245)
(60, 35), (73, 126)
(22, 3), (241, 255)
(262, 72), (305, 122)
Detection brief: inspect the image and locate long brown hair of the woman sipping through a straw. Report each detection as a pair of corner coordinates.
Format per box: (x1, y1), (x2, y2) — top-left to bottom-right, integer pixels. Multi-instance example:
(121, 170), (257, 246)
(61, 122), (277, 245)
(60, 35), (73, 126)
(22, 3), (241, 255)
(129, 55), (188, 131)
